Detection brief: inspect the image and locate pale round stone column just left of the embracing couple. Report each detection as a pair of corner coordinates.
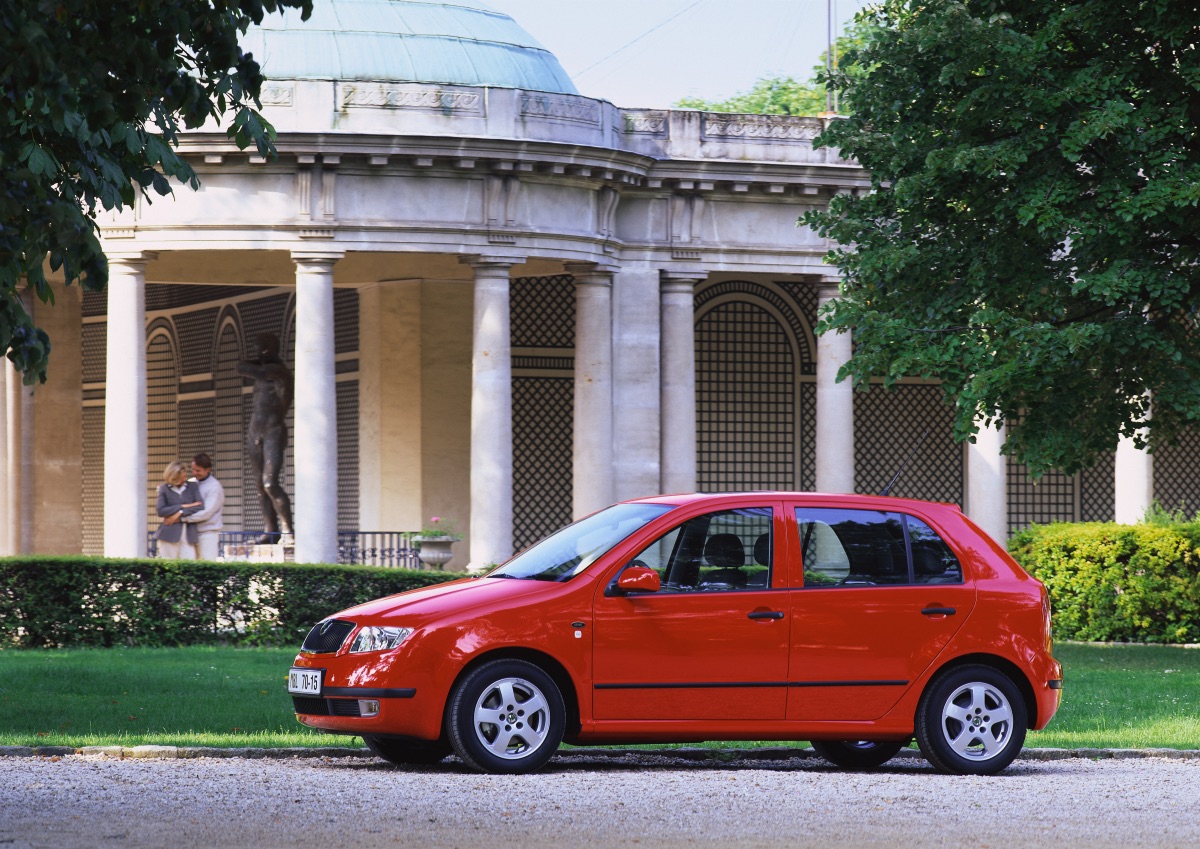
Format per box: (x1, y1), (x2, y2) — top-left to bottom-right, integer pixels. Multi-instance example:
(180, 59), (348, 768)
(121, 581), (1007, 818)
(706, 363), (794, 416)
(104, 251), (157, 558)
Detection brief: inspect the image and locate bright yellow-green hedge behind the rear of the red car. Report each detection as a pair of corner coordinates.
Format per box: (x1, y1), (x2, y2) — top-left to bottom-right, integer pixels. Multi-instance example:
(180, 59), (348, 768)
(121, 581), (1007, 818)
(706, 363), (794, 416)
(1008, 522), (1200, 643)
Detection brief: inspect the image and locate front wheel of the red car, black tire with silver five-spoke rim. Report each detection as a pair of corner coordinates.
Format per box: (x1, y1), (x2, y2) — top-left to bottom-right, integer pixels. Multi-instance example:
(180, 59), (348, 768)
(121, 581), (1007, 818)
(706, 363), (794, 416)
(446, 660), (566, 775)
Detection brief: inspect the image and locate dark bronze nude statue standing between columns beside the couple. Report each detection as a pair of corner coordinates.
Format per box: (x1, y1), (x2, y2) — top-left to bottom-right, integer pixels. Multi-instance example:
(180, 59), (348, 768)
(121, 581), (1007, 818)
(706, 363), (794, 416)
(238, 333), (293, 543)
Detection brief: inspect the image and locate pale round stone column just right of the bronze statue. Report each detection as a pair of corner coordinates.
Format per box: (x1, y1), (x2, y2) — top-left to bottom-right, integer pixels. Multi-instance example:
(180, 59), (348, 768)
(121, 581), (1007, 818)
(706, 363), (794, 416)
(292, 251), (346, 564)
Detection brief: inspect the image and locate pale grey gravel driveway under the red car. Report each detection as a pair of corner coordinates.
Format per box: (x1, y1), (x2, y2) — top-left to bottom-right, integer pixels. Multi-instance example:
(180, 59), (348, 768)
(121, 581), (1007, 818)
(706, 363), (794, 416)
(0, 751), (1200, 849)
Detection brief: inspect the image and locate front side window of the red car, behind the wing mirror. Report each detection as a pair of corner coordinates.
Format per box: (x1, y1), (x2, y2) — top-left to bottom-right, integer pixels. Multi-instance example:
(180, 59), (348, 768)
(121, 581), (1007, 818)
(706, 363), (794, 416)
(630, 507), (773, 592)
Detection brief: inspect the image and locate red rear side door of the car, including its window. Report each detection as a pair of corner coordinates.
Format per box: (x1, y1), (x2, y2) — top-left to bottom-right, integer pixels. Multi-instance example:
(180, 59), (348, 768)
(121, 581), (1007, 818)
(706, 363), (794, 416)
(787, 505), (976, 721)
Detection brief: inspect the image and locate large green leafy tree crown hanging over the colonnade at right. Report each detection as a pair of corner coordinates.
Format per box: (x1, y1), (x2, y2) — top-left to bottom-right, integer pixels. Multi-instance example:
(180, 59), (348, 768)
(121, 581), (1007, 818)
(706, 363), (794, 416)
(803, 0), (1200, 472)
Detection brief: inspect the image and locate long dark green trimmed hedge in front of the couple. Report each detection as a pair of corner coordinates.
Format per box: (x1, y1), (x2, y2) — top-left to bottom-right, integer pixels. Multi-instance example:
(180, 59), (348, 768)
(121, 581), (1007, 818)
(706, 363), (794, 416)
(0, 556), (463, 648)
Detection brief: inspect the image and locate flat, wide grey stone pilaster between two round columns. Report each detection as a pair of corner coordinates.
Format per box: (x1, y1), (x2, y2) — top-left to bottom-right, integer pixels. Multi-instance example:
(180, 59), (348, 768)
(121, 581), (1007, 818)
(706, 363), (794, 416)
(612, 265), (662, 501)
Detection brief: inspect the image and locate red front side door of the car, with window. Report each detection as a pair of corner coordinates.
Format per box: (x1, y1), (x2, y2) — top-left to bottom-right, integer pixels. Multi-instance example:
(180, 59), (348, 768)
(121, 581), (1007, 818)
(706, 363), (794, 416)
(593, 502), (790, 721)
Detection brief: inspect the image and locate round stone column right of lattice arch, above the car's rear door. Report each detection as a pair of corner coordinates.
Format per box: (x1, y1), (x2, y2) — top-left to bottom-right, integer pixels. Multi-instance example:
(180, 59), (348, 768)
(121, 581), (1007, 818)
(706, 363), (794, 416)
(816, 277), (854, 493)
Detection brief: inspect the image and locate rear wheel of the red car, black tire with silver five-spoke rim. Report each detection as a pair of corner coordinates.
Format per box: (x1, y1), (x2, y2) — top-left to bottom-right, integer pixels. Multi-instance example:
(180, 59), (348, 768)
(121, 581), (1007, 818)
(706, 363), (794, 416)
(917, 666), (1028, 776)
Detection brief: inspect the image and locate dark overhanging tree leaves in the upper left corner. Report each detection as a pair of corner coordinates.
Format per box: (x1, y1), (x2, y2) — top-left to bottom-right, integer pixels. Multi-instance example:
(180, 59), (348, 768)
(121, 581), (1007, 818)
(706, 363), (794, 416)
(0, 0), (312, 383)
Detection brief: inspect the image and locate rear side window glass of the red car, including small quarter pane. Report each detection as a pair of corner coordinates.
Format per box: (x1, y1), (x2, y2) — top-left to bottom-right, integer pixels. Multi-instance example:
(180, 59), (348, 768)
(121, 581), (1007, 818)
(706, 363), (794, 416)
(796, 507), (962, 588)
